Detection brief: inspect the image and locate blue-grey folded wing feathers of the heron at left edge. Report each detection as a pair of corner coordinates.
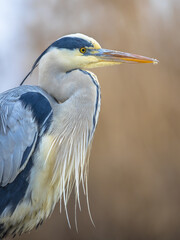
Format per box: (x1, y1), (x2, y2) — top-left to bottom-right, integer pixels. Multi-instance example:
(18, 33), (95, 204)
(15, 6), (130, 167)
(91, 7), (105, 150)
(0, 86), (45, 187)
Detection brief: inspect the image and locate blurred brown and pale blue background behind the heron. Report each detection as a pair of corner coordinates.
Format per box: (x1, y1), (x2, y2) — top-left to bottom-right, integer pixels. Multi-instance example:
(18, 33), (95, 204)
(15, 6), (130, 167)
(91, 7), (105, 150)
(0, 0), (180, 240)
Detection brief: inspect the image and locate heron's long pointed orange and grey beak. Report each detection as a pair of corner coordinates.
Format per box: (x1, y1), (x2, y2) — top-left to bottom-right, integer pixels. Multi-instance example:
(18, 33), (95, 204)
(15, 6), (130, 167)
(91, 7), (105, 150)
(92, 49), (159, 65)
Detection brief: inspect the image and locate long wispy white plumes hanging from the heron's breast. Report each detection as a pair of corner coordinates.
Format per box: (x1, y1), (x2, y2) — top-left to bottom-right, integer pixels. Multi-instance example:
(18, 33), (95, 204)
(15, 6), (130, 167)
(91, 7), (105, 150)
(45, 119), (93, 228)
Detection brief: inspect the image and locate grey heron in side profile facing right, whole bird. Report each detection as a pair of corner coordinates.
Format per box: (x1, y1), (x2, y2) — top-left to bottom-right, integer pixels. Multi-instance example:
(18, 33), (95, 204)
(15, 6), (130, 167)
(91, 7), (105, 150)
(0, 34), (156, 238)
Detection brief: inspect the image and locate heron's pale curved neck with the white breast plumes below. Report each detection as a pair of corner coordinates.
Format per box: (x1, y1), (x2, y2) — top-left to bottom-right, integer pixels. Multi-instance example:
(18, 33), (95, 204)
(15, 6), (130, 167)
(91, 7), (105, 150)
(34, 70), (100, 210)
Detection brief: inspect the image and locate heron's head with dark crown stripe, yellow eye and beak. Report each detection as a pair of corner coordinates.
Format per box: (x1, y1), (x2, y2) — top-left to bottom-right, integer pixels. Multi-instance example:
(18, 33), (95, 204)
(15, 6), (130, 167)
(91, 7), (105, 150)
(39, 33), (158, 71)
